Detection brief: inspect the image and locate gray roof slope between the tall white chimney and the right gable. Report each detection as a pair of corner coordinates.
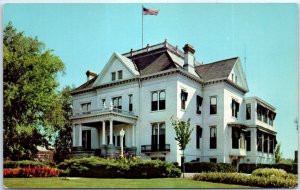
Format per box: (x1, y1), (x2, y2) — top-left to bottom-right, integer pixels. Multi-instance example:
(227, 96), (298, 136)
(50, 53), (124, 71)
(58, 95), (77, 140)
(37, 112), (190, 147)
(195, 57), (238, 81)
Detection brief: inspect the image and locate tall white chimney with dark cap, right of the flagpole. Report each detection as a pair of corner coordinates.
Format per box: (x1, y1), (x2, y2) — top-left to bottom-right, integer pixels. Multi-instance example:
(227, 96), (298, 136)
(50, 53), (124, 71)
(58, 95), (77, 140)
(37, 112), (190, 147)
(183, 44), (198, 76)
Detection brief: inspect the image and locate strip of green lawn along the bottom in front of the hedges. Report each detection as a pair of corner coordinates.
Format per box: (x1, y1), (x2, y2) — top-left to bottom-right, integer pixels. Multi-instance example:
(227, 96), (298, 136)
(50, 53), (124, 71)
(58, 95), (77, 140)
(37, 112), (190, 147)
(3, 177), (253, 189)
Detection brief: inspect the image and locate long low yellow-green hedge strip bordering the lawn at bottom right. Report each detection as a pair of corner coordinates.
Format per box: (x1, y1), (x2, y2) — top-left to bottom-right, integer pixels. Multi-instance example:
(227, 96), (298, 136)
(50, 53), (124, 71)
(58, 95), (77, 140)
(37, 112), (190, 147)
(193, 172), (298, 188)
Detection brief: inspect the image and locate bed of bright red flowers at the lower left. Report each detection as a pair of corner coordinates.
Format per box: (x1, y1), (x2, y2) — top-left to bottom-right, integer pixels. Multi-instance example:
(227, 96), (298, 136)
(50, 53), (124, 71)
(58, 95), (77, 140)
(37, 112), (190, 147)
(3, 166), (59, 178)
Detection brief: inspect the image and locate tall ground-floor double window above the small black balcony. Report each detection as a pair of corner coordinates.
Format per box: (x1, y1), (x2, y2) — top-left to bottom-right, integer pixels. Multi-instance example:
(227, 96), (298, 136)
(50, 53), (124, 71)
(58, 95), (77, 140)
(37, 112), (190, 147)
(151, 123), (166, 151)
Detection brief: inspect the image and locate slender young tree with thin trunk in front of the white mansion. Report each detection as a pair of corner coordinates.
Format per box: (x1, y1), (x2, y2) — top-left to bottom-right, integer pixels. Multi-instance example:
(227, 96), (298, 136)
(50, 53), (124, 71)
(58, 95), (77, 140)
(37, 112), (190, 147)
(171, 118), (193, 177)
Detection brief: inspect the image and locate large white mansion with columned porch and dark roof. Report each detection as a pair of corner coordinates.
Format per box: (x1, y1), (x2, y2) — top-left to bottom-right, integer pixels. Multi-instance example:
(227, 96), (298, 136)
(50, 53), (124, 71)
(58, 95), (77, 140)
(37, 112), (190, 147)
(71, 41), (276, 164)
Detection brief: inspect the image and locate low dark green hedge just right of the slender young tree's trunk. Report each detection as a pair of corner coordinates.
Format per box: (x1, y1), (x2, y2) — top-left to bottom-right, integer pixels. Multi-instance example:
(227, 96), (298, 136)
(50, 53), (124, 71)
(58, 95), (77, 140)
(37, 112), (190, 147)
(184, 162), (236, 173)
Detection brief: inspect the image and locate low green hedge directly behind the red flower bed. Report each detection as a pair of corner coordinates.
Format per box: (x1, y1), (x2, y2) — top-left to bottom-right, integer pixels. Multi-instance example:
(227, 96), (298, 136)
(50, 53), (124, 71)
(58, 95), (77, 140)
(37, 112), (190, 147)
(3, 160), (55, 168)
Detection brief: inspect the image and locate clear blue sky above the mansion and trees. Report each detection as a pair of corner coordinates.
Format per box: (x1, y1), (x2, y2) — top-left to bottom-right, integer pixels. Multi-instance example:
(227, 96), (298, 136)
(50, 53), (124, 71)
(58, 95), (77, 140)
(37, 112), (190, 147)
(3, 3), (299, 158)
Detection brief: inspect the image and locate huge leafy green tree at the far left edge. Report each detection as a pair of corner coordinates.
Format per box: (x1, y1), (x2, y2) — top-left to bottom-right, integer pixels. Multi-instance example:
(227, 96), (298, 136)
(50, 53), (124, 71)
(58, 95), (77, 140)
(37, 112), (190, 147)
(3, 23), (64, 160)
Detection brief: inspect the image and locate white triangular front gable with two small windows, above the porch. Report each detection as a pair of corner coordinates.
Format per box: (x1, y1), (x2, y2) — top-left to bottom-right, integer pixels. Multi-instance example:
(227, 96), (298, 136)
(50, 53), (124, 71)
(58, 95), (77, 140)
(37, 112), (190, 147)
(93, 52), (139, 87)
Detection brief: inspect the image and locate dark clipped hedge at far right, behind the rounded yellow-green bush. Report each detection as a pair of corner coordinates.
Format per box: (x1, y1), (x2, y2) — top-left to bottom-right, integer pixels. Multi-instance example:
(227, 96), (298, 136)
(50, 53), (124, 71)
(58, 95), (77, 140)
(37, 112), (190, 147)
(239, 163), (298, 174)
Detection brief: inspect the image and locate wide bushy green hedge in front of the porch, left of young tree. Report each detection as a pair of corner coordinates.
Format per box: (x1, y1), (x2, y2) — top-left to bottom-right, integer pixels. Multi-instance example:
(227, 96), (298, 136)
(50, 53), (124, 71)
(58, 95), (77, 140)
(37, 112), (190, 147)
(58, 157), (181, 178)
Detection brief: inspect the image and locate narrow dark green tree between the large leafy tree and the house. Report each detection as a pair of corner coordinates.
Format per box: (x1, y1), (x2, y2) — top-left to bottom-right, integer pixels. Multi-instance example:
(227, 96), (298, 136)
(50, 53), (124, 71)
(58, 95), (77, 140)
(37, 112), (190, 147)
(54, 86), (74, 162)
